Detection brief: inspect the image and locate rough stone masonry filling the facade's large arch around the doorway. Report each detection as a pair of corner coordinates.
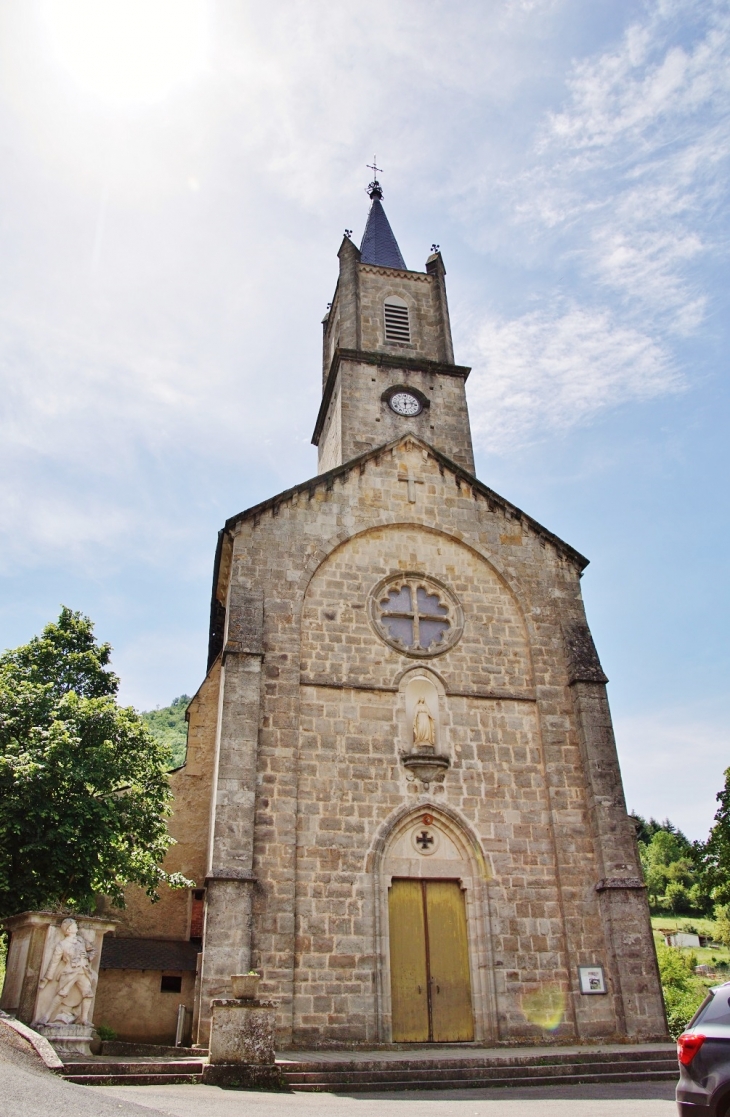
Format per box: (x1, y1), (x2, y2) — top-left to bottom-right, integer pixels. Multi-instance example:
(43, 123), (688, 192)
(295, 526), (615, 1042)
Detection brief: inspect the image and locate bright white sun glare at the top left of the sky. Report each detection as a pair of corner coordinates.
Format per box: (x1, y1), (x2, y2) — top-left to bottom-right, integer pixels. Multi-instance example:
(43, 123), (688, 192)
(44, 0), (209, 103)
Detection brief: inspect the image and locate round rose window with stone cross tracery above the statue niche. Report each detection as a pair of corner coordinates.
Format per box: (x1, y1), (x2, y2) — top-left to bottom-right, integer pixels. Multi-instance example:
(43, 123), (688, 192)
(371, 574), (462, 656)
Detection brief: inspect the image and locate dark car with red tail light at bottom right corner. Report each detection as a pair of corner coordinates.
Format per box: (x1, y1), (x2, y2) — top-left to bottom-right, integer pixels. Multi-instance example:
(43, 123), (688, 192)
(676, 982), (730, 1117)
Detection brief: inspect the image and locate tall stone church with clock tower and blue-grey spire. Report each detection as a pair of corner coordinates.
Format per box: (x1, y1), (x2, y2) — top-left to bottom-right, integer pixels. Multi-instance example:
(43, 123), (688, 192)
(95, 172), (666, 1048)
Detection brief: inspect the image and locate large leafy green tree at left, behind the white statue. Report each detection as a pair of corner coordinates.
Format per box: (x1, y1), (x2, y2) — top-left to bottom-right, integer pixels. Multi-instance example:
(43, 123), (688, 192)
(0, 608), (190, 916)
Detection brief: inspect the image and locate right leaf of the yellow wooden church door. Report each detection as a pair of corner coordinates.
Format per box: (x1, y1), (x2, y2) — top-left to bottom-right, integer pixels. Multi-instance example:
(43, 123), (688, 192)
(425, 880), (474, 1043)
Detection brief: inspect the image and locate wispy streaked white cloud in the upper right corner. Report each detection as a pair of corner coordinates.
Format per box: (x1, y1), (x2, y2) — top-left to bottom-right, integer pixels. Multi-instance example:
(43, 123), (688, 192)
(518, 0), (730, 326)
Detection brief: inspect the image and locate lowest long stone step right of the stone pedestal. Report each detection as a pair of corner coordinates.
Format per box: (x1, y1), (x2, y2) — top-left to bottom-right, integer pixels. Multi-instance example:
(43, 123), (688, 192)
(285, 1069), (679, 1094)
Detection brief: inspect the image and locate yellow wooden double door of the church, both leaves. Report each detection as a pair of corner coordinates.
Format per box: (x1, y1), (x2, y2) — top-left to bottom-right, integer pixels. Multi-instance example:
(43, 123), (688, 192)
(388, 878), (474, 1043)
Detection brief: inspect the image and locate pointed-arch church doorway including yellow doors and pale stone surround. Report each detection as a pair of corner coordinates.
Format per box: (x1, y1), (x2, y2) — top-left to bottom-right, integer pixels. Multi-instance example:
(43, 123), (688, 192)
(371, 800), (497, 1043)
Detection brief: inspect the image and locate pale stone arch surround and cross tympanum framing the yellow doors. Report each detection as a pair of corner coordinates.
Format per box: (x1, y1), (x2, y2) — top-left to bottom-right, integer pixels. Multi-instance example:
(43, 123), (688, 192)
(367, 796), (497, 1043)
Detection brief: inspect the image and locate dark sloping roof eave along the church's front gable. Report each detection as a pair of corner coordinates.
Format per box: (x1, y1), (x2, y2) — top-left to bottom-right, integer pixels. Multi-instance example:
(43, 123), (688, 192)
(223, 435), (589, 571)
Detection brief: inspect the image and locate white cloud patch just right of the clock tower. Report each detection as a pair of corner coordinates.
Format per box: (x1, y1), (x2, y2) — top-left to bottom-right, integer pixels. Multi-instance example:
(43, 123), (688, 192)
(468, 306), (682, 451)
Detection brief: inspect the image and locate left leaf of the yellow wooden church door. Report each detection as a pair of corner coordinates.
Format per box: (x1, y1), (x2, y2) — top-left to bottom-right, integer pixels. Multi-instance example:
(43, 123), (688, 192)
(388, 880), (430, 1043)
